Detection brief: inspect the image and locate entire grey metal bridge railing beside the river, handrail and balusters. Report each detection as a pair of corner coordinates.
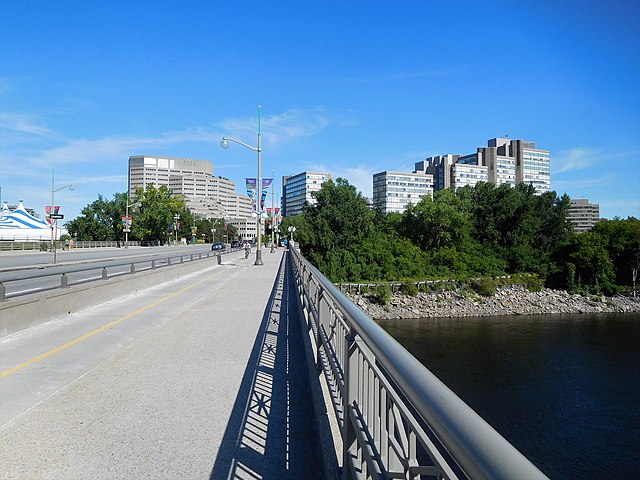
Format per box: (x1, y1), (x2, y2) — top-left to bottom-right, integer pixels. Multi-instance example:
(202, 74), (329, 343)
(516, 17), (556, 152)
(290, 249), (547, 480)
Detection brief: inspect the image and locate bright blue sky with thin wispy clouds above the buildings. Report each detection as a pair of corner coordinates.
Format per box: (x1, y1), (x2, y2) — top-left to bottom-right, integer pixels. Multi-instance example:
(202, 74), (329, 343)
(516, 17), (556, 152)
(0, 0), (640, 220)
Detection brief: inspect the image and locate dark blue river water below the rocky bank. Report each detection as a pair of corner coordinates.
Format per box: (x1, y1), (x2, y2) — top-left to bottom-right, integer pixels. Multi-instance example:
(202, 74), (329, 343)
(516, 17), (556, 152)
(379, 314), (640, 479)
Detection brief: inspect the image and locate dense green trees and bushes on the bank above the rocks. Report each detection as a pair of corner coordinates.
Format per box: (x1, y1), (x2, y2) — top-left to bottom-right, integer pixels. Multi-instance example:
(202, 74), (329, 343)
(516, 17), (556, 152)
(281, 178), (640, 295)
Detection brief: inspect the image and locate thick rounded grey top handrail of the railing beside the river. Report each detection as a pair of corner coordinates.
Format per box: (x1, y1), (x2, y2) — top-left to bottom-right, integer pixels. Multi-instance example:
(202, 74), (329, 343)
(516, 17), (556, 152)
(290, 249), (547, 480)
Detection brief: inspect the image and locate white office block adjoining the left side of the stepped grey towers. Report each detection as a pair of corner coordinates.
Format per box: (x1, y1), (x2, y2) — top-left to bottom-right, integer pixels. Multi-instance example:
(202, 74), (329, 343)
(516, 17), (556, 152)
(373, 172), (433, 213)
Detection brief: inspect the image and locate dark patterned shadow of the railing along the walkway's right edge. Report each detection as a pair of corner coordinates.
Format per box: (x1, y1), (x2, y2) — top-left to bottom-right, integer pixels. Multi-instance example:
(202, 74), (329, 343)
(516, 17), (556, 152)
(210, 256), (323, 480)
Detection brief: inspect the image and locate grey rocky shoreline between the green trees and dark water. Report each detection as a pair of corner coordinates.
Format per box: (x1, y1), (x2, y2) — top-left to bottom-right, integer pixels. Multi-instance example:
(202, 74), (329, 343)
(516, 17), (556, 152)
(347, 285), (640, 320)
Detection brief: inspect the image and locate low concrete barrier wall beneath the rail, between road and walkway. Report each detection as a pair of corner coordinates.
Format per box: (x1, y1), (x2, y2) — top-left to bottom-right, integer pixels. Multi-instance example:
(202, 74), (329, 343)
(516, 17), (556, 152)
(0, 256), (218, 338)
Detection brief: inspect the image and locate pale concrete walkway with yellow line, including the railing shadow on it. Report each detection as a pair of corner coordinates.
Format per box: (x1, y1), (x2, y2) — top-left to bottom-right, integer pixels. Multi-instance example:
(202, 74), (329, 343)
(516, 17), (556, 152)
(0, 250), (323, 480)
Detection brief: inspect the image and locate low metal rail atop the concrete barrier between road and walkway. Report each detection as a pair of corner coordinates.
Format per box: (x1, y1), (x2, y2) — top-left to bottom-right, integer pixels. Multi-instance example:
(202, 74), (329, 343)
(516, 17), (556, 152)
(0, 249), (229, 302)
